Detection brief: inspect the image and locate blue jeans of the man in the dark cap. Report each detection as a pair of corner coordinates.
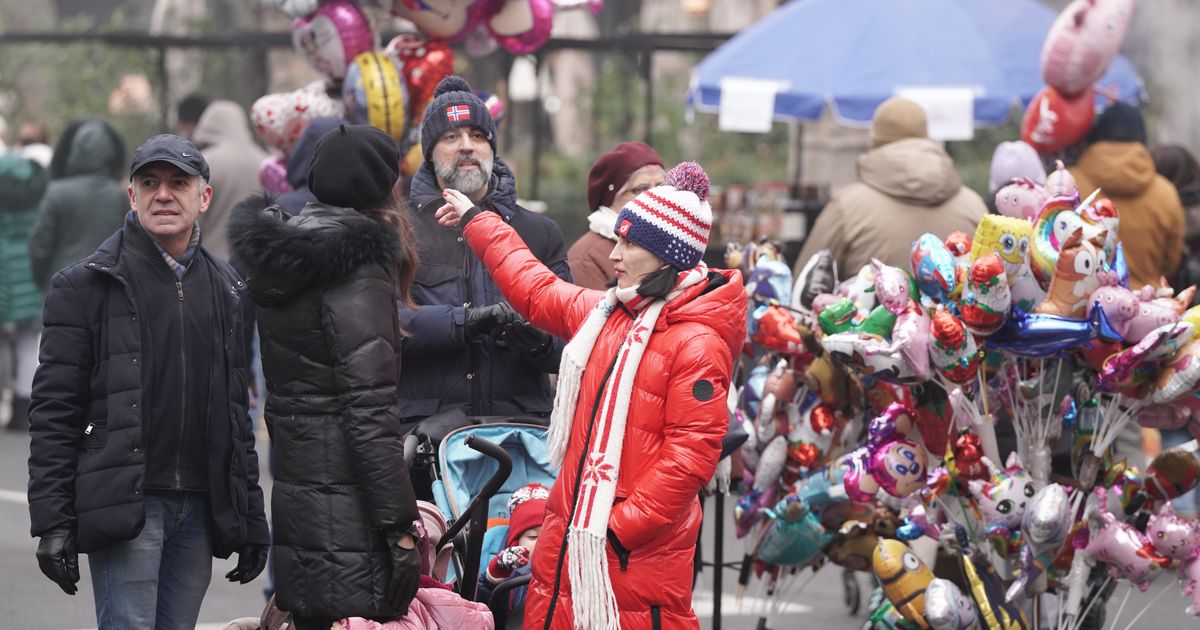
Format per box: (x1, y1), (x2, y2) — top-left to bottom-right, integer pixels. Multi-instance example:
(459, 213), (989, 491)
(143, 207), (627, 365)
(88, 492), (212, 630)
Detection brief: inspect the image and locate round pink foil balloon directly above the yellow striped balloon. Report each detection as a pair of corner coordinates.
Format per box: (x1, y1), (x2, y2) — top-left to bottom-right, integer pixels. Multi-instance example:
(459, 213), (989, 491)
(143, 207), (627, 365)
(292, 0), (376, 80)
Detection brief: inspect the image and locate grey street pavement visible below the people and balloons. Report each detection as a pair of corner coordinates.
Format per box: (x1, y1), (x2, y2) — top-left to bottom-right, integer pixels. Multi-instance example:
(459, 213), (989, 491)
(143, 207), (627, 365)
(0, 428), (1198, 630)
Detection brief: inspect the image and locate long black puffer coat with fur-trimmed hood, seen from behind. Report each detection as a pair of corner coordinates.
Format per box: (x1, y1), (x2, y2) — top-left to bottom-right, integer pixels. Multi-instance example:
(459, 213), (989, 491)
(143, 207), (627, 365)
(229, 196), (419, 619)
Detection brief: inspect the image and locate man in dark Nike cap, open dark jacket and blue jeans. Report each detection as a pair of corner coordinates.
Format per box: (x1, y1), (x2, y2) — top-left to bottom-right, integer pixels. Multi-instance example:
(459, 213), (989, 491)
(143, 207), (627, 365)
(29, 134), (270, 629)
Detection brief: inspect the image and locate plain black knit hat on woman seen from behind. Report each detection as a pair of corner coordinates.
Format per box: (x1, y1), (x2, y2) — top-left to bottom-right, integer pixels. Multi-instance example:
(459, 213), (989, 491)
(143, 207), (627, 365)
(308, 125), (400, 210)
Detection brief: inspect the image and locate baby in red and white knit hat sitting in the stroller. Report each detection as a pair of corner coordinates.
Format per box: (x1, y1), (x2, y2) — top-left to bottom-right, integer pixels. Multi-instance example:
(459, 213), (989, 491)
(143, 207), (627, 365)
(476, 484), (550, 629)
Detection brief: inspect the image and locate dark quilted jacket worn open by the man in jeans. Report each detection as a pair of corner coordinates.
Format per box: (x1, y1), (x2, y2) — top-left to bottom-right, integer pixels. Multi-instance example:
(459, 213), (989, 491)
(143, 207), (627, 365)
(29, 214), (270, 558)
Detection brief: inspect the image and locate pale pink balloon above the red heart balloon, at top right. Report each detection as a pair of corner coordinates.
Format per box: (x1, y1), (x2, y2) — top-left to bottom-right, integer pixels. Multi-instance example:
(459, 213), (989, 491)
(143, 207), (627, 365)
(1042, 0), (1134, 95)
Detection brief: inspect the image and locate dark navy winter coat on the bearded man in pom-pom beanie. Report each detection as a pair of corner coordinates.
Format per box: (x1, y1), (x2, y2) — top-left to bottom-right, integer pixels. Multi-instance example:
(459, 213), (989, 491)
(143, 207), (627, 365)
(400, 158), (571, 421)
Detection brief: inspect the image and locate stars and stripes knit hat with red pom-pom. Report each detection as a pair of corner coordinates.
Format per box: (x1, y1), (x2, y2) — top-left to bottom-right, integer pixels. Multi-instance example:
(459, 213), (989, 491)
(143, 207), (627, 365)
(614, 162), (713, 271)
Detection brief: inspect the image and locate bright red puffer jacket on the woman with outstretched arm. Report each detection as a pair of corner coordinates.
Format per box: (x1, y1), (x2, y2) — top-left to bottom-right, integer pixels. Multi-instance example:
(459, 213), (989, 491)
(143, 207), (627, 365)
(464, 212), (746, 630)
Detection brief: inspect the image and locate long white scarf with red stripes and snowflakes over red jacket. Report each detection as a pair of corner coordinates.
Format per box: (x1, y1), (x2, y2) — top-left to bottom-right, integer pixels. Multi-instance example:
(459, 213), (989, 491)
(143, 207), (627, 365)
(550, 263), (708, 630)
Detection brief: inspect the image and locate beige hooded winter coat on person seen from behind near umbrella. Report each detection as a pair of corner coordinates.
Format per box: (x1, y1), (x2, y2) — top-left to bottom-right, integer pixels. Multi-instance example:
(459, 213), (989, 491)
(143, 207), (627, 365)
(796, 138), (988, 278)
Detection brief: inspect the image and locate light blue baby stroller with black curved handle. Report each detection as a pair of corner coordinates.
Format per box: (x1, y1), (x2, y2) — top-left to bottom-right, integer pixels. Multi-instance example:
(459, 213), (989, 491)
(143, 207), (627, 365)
(406, 416), (554, 628)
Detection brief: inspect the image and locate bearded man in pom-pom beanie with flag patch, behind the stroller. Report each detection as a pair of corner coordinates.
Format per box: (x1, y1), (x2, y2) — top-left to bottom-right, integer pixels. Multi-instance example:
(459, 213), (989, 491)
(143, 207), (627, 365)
(400, 76), (571, 432)
